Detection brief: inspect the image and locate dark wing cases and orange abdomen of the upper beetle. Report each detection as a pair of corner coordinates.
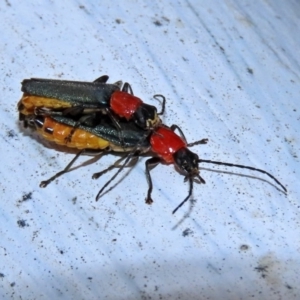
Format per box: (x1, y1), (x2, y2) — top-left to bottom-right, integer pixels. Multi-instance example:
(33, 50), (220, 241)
(18, 75), (122, 119)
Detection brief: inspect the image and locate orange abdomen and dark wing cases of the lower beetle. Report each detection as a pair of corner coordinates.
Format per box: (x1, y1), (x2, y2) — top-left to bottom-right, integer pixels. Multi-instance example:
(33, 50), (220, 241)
(23, 115), (149, 152)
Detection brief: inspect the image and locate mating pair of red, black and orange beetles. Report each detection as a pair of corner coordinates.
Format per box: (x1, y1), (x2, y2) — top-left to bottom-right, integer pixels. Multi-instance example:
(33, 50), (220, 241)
(18, 76), (286, 213)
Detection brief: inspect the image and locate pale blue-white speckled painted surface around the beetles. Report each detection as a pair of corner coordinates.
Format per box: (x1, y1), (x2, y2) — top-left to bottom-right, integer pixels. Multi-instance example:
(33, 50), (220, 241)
(0, 0), (300, 299)
